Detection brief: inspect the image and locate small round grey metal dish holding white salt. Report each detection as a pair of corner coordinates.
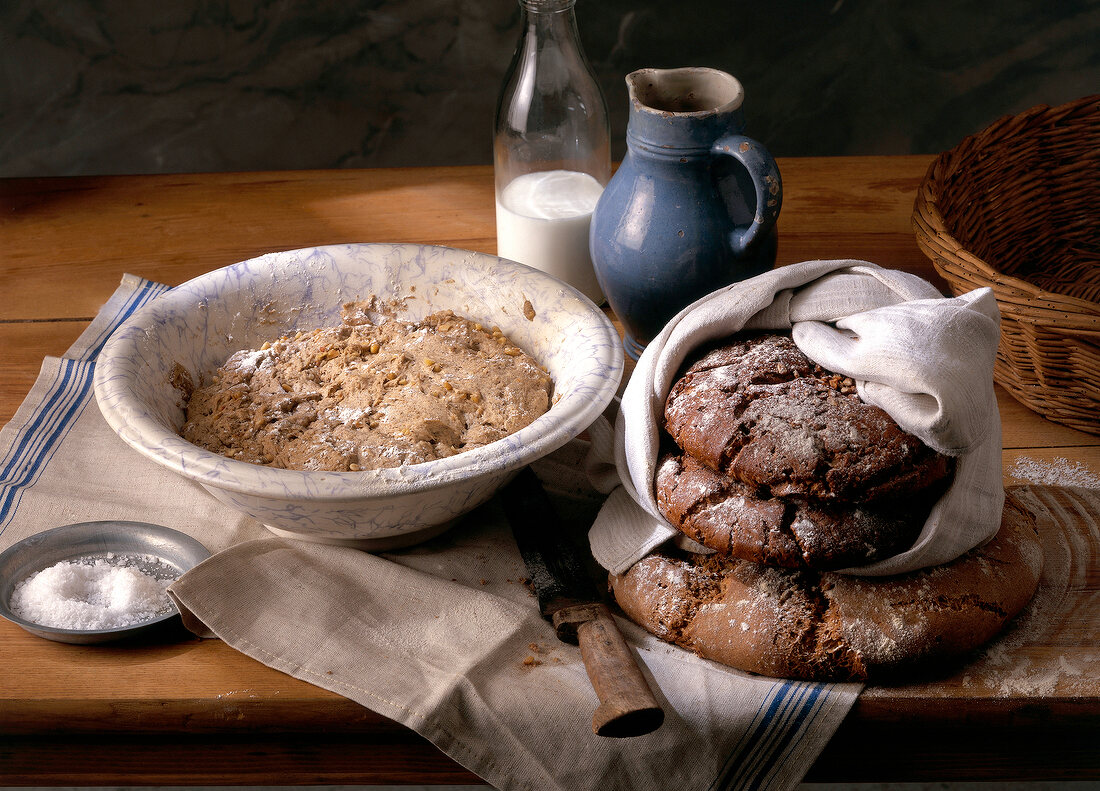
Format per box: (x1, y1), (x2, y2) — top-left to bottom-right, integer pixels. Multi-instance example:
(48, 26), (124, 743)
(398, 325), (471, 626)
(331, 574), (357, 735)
(0, 520), (210, 645)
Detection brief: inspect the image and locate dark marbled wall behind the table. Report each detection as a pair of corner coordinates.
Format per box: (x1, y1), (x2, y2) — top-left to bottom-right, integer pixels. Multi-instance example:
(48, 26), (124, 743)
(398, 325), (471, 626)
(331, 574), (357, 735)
(0, 0), (1100, 176)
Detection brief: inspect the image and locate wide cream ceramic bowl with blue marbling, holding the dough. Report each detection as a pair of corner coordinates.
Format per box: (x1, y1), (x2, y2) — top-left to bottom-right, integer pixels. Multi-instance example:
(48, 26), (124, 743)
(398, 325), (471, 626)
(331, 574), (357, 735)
(95, 244), (623, 549)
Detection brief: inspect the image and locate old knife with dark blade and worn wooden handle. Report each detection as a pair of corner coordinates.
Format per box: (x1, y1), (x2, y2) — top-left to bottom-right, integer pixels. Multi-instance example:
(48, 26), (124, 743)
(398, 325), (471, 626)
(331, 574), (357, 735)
(501, 468), (664, 737)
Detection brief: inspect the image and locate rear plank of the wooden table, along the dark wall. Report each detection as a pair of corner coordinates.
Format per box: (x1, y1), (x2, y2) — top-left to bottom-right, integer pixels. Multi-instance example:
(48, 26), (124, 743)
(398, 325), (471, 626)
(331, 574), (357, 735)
(0, 156), (931, 319)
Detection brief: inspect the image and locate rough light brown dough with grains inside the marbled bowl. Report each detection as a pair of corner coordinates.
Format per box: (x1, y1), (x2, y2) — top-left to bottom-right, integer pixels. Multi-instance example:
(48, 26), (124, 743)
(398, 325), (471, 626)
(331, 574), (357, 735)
(180, 301), (553, 471)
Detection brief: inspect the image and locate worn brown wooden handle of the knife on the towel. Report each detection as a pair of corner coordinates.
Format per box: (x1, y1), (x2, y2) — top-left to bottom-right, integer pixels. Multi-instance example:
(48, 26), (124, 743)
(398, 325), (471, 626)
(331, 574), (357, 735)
(553, 603), (664, 737)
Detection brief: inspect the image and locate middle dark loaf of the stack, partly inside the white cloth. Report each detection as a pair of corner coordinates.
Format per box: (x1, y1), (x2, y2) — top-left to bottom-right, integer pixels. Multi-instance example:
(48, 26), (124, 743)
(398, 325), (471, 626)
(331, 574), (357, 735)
(656, 453), (935, 570)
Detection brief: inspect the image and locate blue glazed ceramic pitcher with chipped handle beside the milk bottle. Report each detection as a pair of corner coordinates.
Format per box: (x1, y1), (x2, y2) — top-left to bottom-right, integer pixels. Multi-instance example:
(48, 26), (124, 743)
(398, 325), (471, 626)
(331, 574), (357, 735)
(589, 67), (783, 359)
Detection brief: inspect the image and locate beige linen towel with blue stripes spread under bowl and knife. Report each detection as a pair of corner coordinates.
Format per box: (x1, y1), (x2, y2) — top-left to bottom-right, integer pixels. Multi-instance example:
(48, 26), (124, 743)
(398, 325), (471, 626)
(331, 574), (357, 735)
(0, 276), (860, 791)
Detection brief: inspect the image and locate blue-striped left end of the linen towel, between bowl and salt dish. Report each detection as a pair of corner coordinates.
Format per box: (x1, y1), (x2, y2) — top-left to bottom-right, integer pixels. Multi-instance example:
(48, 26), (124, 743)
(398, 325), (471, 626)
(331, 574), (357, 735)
(0, 275), (266, 551)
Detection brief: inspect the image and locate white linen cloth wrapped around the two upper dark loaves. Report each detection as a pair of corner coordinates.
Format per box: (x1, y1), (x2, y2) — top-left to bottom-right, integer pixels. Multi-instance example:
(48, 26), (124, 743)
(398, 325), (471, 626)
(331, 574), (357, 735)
(589, 260), (1004, 575)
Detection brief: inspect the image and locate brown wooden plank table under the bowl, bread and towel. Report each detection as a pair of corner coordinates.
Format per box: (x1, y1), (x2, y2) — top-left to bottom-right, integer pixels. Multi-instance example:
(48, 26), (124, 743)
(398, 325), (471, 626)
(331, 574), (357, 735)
(0, 156), (1100, 785)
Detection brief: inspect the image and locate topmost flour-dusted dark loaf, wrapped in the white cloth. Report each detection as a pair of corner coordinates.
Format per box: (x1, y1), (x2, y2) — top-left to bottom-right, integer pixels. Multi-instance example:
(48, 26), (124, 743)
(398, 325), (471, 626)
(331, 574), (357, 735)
(664, 333), (952, 502)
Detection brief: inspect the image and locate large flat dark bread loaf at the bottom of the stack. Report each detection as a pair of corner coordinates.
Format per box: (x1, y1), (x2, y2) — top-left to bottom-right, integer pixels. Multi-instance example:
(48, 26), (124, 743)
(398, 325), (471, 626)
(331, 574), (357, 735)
(611, 493), (1043, 681)
